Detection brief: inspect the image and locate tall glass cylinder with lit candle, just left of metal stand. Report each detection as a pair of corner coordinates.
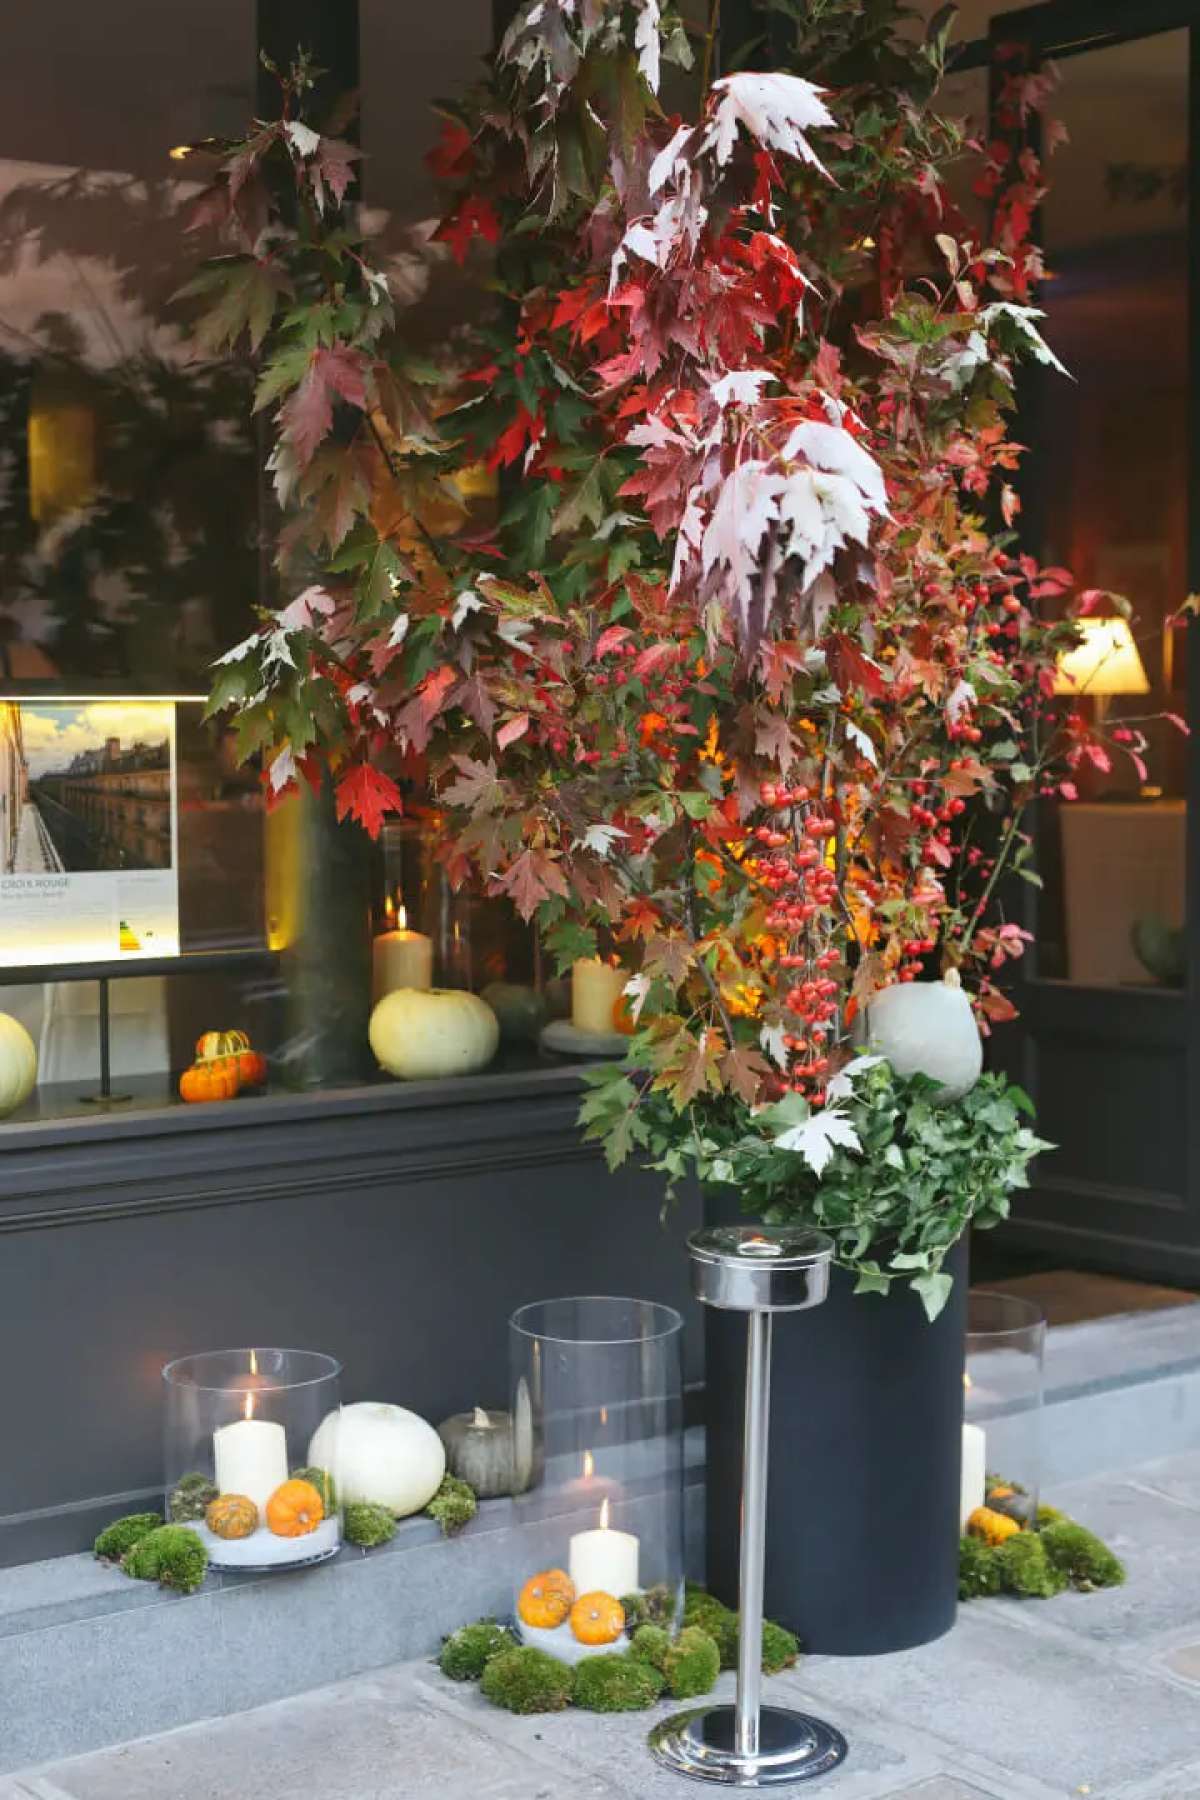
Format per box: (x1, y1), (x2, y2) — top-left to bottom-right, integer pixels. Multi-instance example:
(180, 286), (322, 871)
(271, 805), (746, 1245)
(509, 1296), (684, 1663)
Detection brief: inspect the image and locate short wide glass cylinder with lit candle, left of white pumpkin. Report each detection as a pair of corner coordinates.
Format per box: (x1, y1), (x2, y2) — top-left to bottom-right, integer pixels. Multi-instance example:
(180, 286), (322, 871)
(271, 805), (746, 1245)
(162, 1346), (342, 1570)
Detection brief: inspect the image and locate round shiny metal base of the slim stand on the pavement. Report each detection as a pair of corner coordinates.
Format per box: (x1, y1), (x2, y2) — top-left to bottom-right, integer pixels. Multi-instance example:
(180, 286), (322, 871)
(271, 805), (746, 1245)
(649, 1706), (847, 1787)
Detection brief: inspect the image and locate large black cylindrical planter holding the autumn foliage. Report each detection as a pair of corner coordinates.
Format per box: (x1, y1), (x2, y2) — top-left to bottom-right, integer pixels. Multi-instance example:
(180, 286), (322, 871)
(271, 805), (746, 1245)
(705, 1209), (966, 1656)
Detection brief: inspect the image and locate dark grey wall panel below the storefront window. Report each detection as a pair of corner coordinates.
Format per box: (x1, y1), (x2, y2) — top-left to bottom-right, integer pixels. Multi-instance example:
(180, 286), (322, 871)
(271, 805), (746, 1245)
(0, 1071), (702, 1562)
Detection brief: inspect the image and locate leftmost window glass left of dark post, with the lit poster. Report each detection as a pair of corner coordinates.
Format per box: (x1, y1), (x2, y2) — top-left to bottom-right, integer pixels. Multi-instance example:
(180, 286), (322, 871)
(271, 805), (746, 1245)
(0, 0), (272, 1112)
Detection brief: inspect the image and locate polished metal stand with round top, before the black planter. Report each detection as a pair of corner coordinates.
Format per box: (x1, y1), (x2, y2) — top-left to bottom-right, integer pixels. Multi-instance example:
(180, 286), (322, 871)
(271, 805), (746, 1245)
(649, 1226), (846, 1787)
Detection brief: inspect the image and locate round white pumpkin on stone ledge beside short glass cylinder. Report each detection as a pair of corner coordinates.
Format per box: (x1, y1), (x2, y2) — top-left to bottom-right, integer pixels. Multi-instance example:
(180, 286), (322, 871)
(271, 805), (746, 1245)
(308, 1400), (446, 1519)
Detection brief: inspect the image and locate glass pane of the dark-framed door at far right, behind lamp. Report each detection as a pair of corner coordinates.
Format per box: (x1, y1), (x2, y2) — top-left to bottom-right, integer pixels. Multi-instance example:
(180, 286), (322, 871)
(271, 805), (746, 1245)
(1029, 31), (1187, 986)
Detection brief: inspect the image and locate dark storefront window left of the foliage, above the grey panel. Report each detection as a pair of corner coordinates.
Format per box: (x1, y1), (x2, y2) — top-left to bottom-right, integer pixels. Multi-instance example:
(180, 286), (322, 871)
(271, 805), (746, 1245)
(0, 0), (518, 1121)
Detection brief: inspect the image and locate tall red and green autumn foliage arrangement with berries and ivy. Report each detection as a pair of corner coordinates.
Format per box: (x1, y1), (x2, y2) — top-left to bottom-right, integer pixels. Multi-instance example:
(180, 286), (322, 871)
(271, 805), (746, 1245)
(194, 0), (1180, 1310)
